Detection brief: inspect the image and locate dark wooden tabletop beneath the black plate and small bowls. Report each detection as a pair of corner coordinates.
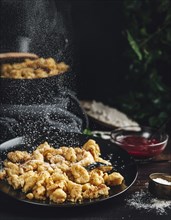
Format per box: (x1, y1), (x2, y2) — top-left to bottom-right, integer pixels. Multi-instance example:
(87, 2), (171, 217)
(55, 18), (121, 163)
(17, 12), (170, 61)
(0, 128), (171, 220)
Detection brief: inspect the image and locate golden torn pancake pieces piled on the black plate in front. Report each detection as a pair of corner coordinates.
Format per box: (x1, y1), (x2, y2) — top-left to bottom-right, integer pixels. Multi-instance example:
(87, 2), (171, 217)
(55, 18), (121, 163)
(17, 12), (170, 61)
(0, 139), (124, 203)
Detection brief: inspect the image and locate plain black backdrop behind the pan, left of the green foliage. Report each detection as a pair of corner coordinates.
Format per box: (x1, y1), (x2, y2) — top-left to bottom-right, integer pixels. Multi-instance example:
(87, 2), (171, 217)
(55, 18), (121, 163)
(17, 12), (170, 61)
(0, 0), (127, 102)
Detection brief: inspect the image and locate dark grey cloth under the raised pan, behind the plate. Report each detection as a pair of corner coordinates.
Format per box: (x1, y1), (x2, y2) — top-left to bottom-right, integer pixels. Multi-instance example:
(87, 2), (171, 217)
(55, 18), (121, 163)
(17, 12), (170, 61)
(0, 90), (88, 143)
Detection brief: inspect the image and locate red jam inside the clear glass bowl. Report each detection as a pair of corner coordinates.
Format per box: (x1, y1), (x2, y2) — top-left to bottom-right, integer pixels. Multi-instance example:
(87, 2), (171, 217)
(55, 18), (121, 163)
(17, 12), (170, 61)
(117, 135), (165, 159)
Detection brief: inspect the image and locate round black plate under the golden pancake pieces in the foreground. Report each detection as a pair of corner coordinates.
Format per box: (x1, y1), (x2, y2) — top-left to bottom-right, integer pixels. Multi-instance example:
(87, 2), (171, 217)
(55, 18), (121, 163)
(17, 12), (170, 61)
(0, 133), (137, 207)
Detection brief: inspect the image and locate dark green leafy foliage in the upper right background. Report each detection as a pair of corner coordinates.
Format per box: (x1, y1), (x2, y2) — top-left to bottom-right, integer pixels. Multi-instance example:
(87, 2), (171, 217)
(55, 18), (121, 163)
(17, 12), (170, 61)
(118, 0), (171, 126)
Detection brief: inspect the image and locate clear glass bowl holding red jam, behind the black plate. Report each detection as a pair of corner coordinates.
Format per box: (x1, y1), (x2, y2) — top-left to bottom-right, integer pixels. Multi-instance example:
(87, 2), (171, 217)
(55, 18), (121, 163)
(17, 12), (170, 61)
(111, 126), (169, 159)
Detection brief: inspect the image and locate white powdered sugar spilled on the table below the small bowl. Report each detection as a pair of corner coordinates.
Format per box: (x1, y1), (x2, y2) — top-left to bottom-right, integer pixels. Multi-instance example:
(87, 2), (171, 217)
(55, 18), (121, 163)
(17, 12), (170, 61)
(126, 190), (171, 215)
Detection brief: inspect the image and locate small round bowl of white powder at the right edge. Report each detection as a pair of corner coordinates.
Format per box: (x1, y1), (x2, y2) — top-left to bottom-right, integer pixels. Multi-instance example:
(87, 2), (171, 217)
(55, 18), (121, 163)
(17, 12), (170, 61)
(148, 173), (171, 199)
